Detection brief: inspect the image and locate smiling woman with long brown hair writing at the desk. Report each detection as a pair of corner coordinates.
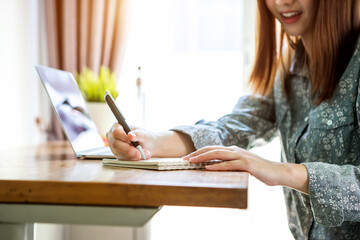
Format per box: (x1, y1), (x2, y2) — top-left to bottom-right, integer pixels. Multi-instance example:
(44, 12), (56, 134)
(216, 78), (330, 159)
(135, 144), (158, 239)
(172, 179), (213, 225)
(107, 0), (360, 239)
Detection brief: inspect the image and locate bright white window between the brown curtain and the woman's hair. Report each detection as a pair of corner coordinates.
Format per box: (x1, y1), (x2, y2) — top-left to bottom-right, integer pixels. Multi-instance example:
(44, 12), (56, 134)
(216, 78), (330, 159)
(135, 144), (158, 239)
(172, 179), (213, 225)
(118, 0), (254, 130)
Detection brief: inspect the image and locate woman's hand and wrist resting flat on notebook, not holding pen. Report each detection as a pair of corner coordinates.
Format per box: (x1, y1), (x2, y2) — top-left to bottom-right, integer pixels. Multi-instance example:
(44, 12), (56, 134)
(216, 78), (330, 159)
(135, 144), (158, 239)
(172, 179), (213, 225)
(184, 146), (308, 193)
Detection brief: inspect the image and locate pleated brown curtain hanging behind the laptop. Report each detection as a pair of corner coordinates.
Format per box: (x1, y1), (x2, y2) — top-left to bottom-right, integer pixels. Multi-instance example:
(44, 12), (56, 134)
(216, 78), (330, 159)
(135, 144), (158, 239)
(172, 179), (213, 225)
(44, 0), (130, 140)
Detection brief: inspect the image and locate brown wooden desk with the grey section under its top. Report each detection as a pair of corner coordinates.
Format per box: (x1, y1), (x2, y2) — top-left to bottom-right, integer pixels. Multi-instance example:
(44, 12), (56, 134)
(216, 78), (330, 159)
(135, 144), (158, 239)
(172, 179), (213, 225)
(0, 142), (248, 239)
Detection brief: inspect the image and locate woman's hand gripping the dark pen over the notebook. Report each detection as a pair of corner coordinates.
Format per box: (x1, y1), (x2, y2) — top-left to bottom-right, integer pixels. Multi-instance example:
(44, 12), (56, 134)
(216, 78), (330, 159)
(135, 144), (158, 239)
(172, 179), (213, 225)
(106, 123), (156, 161)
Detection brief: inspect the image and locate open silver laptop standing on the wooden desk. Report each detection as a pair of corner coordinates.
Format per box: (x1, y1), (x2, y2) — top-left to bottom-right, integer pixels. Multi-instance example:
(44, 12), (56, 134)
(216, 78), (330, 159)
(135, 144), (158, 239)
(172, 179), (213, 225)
(35, 65), (115, 159)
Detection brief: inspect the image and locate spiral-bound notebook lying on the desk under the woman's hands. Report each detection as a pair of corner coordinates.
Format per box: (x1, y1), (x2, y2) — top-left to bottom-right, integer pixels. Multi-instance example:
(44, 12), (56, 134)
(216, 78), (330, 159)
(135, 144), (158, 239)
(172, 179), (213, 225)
(102, 158), (221, 170)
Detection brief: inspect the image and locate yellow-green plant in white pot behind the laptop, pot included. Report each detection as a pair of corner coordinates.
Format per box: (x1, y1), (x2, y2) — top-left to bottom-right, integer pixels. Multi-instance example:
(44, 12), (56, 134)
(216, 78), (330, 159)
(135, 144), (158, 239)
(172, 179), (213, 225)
(76, 66), (119, 137)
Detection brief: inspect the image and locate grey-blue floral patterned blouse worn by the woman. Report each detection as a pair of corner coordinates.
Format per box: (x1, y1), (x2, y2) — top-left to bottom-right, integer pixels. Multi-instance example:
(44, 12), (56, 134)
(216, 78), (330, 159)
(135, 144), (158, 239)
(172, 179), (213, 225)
(173, 39), (360, 239)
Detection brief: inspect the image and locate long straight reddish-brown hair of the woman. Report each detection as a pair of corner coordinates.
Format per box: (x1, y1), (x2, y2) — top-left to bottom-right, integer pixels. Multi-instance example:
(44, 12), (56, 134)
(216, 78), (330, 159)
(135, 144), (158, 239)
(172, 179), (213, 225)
(249, 0), (360, 103)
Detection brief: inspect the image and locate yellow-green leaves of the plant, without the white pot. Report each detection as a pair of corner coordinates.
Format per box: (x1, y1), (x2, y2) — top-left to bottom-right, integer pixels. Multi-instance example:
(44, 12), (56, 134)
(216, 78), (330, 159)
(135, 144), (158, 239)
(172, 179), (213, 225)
(76, 66), (119, 102)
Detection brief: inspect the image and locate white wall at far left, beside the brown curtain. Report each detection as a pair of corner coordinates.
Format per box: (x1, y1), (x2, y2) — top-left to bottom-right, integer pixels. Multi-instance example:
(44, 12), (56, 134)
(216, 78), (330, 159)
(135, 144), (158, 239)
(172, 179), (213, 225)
(0, 0), (43, 149)
